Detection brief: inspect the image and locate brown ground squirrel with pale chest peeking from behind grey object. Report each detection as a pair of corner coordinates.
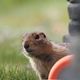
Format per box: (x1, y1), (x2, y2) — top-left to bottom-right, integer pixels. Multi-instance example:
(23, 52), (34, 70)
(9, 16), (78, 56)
(23, 32), (69, 80)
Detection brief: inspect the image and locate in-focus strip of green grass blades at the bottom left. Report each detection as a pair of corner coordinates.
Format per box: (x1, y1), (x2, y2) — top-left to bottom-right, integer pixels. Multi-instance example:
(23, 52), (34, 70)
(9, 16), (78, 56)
(0, 65), (38, 80)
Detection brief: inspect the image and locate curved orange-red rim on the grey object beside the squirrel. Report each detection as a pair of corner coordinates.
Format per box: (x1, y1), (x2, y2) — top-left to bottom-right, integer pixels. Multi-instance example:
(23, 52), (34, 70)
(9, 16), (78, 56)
(48, 55), (72, 80)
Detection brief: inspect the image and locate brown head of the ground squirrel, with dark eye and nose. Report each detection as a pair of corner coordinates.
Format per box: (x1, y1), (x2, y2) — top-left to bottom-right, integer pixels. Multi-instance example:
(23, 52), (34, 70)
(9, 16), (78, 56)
(23, 32), (51, 57)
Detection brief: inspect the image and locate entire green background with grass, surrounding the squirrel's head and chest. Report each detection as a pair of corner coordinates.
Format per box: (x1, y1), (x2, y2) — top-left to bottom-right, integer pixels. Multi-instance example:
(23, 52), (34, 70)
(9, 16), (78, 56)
(0, 0), (69, 80)
